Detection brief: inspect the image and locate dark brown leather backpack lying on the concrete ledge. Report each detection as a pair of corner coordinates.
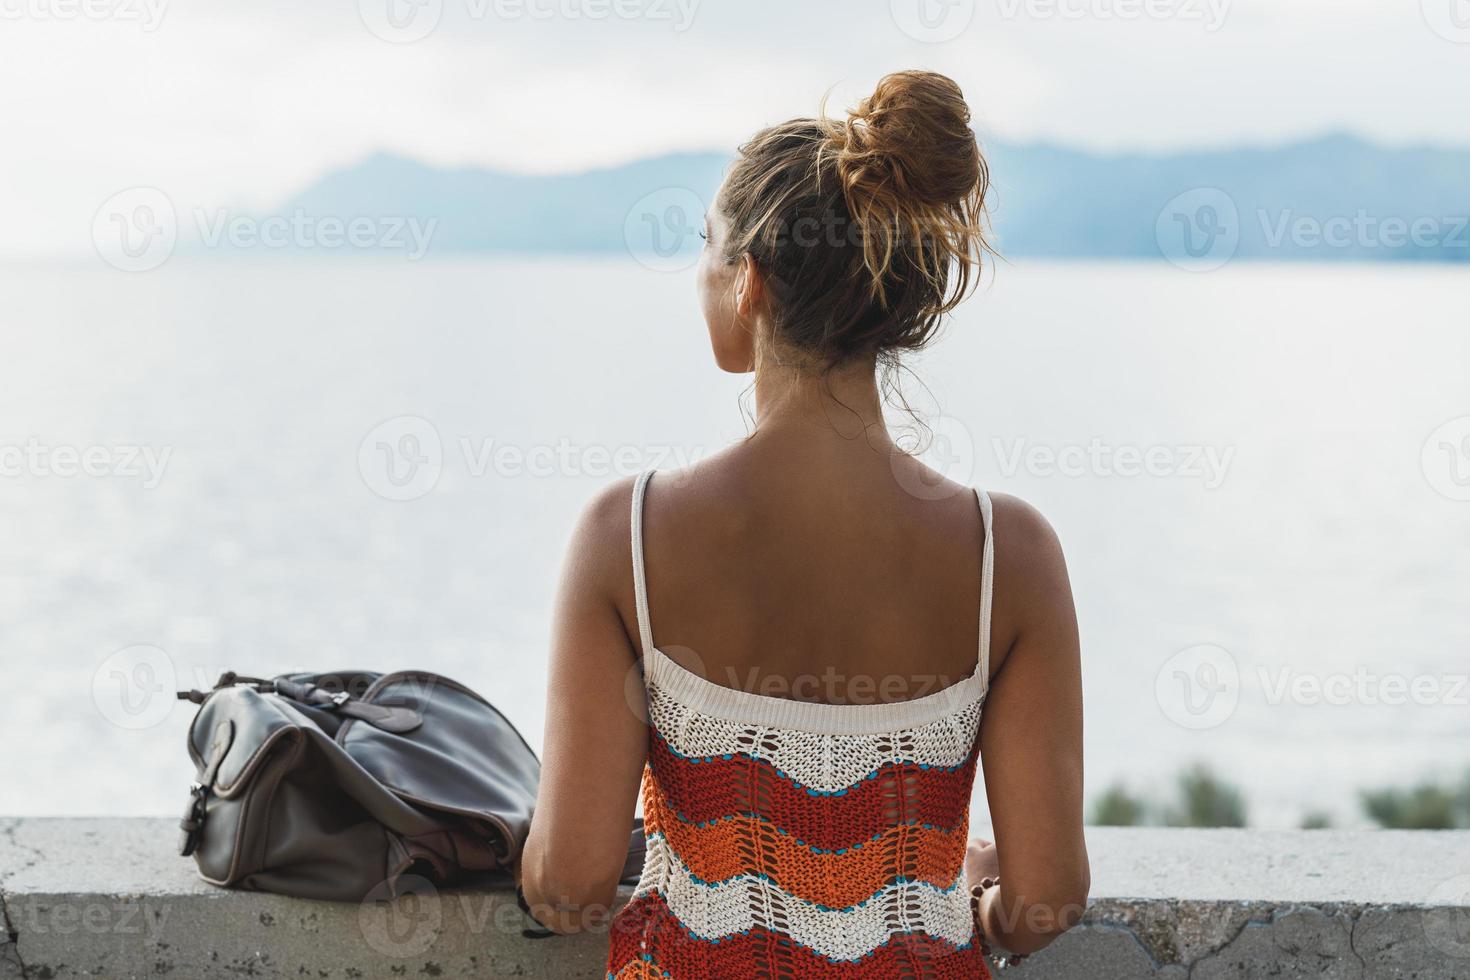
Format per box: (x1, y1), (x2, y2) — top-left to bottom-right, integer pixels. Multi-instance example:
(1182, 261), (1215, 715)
(179, 670), (642, 901)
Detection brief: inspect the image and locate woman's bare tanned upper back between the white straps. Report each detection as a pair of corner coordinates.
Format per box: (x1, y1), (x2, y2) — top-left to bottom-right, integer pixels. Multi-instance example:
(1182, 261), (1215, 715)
(626, 437), (985, 704)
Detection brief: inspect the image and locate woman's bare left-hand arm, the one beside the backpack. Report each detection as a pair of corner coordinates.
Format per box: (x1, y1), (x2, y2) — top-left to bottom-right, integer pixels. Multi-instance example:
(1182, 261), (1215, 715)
(520, 480), (648, 933)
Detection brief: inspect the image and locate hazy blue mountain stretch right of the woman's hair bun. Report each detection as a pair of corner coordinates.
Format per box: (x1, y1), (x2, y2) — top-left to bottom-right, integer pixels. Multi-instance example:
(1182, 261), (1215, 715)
(989, 137), (1470, 262)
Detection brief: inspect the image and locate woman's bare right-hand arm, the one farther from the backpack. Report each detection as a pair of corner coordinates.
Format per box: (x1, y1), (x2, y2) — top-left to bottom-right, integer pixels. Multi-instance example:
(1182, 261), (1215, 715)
(970, 497), (1091, 954)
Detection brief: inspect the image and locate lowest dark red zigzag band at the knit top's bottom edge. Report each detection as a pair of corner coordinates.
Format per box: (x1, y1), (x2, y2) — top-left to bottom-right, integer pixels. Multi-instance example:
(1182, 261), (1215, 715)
(609, 895), (986, 980)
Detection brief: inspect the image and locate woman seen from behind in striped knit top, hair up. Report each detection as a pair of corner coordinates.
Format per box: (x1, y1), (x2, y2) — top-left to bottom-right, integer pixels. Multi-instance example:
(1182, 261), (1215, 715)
(520, 72), (1089, 980)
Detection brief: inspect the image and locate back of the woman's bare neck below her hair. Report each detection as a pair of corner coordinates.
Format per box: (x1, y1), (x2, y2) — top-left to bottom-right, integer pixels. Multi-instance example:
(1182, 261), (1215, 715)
(756, 360), (894, 453)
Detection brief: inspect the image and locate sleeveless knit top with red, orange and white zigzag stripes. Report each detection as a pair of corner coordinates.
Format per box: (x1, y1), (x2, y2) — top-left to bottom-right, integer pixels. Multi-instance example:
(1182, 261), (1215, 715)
(607, 473), (995, 980)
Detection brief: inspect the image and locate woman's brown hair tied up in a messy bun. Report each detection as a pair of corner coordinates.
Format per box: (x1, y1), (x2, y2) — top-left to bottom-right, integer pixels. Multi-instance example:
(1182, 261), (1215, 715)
(717, 72), (989, 369)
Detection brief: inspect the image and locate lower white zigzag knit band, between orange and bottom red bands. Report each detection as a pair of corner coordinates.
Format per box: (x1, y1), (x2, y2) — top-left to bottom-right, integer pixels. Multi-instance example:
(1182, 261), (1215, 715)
(634, 836), (973, 959)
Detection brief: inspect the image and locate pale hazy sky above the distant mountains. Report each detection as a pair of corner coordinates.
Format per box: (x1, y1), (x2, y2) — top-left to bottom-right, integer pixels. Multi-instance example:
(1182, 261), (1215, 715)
(0, 0), (1470, 253)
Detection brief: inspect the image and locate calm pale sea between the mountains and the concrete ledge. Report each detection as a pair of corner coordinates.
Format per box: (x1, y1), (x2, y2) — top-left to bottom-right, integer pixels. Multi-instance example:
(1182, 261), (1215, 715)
(0, 260), (1470, 826)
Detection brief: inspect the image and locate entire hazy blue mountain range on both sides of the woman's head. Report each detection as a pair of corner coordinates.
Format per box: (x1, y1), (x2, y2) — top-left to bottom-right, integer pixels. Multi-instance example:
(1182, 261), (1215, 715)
(276, 135), (1470, 267)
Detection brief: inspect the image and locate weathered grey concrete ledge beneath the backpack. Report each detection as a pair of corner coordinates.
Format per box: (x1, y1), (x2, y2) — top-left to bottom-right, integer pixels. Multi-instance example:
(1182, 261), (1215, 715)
(0, 820), (1470, 980)
